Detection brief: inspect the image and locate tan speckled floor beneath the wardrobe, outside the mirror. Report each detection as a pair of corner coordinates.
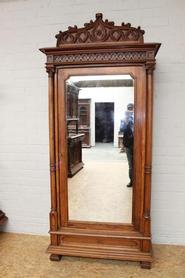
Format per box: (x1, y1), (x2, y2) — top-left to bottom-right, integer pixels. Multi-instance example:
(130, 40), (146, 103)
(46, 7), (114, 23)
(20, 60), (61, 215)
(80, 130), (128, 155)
(0, 233), (185, 278)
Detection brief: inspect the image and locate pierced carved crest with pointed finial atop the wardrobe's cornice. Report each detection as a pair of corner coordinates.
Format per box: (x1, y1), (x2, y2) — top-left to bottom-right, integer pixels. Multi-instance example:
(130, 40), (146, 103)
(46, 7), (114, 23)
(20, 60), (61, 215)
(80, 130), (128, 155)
(56, 13), (144, 47)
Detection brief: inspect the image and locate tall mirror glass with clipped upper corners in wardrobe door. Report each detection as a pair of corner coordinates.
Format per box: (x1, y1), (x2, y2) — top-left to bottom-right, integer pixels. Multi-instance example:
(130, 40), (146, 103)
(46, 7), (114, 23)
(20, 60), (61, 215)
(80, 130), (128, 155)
(66, 75), (134, 223)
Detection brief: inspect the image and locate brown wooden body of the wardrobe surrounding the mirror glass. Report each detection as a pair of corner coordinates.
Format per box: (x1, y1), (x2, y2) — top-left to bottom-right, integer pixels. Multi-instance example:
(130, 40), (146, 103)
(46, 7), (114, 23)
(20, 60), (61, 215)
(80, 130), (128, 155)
(40, 14), (160, 268)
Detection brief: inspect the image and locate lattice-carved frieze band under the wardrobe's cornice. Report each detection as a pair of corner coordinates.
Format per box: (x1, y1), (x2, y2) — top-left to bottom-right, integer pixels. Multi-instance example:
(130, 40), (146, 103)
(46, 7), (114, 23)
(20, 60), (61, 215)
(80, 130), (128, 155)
(53, 51), (146, 63)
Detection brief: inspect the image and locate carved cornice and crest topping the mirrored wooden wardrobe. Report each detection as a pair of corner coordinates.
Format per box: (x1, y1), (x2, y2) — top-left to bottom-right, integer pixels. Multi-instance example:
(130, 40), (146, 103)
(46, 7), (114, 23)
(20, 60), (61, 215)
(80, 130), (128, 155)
(40, 13), (160, 69)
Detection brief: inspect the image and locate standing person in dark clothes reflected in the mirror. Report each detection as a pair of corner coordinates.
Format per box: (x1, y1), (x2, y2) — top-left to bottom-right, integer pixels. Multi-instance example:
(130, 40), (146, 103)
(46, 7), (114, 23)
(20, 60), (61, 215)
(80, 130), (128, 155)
(120, 103), (134, 187)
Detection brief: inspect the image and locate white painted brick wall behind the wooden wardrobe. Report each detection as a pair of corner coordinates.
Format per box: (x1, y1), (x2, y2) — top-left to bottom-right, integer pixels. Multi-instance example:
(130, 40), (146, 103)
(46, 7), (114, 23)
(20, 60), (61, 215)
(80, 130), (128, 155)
(0, 0), (185, 244)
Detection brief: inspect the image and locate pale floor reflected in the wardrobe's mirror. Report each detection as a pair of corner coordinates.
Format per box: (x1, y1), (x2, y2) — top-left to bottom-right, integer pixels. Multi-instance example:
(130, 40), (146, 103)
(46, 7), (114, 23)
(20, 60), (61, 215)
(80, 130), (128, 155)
(68, 143), (132, 223)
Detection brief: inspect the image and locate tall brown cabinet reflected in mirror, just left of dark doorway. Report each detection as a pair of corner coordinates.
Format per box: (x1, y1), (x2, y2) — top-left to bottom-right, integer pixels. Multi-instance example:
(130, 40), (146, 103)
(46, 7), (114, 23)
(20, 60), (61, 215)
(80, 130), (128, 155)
(78, 99), (91, 148)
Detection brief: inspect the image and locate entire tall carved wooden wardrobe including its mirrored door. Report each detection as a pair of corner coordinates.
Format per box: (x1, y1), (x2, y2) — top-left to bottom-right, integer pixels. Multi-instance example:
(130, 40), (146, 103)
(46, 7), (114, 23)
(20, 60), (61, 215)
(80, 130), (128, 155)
(40, 14), (160, 268)
